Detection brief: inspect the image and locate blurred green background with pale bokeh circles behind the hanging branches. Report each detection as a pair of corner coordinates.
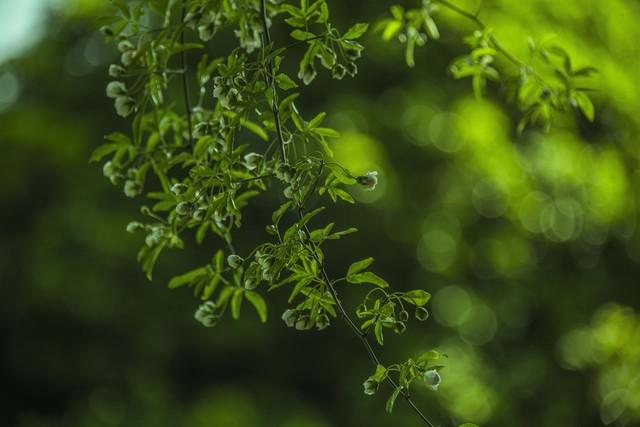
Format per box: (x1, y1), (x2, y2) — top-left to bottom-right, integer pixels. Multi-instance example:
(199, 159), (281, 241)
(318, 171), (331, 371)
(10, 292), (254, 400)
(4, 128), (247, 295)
(0, 0), (640, 427)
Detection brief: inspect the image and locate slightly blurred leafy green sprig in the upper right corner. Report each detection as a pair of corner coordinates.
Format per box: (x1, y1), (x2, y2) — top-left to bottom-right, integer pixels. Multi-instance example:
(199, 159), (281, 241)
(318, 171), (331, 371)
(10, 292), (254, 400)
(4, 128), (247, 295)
(376, 0), (597, 133)
